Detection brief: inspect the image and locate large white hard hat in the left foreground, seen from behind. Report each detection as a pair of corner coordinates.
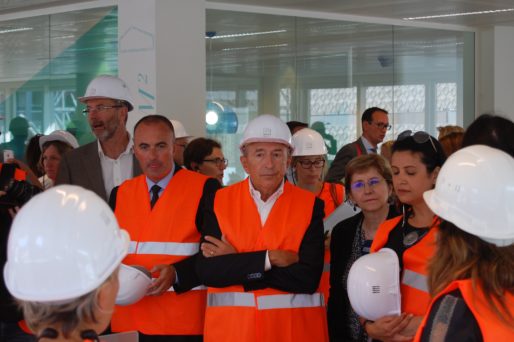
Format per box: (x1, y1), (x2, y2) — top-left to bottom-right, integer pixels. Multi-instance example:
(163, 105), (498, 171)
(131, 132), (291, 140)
(4, 185), (130, 303)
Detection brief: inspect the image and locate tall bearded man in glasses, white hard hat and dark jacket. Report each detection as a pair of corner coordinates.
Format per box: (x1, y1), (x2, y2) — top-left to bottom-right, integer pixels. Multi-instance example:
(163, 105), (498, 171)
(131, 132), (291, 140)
(56, 75), (141, 201)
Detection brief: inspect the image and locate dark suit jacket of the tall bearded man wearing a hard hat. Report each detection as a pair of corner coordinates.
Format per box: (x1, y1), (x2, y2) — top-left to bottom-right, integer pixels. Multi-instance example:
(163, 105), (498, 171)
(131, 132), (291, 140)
(55, 140), (141, 202)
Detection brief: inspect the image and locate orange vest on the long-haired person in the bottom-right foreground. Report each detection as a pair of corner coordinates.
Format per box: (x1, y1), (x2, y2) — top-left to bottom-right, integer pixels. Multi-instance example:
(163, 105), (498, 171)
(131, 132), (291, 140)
(414, 279), (514, 342)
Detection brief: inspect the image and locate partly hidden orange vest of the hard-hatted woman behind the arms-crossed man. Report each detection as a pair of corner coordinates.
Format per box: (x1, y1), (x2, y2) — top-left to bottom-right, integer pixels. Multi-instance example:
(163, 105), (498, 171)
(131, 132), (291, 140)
(318, 182), (344, 306)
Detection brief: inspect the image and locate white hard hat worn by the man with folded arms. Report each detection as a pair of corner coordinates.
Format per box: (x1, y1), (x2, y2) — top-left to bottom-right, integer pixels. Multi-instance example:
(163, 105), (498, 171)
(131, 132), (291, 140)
(239, 114), (293, 149)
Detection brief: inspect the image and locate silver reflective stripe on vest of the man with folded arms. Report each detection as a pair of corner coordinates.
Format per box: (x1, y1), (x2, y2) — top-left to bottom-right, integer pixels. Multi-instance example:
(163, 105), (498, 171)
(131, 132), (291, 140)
(257, 293), (325, 310)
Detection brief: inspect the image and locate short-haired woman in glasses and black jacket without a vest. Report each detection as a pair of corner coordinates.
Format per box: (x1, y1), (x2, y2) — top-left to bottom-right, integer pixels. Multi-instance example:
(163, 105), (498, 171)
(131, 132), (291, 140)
(328, 154), (396, 341)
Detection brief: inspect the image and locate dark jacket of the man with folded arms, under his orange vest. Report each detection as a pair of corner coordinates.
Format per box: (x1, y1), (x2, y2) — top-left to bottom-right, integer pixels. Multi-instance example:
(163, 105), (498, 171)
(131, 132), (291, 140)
(196, 187), (324, 293)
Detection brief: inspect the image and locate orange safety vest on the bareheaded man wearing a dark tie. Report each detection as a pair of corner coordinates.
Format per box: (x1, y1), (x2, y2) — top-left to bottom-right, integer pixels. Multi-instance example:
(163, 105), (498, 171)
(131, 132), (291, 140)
(111, 169), (207, 335)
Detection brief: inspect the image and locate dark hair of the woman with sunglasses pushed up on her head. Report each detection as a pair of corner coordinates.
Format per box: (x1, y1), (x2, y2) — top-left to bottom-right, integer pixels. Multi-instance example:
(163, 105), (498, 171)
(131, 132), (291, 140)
(391, 133), (446, 173)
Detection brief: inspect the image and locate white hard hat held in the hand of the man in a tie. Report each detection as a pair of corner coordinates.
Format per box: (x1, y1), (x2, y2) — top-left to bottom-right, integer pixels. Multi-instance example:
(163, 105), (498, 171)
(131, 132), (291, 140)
(116, 264), (152, 305)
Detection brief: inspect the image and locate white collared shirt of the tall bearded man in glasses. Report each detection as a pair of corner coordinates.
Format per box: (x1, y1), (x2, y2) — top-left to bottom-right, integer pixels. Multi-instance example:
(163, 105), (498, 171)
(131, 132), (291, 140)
(97, 135), (134, 197)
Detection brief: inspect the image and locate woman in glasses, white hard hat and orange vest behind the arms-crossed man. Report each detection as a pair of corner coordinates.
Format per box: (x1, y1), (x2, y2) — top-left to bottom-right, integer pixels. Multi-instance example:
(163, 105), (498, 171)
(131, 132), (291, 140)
(291, 128), (344, 305)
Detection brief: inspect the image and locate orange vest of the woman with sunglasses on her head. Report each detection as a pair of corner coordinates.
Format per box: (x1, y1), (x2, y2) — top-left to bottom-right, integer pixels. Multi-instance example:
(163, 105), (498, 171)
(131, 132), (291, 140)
(371, 216), (439, 316)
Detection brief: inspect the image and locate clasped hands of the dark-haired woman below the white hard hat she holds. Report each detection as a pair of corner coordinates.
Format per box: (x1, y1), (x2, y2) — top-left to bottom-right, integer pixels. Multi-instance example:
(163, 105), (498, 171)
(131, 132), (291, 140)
(365, 313), (416, 342)
